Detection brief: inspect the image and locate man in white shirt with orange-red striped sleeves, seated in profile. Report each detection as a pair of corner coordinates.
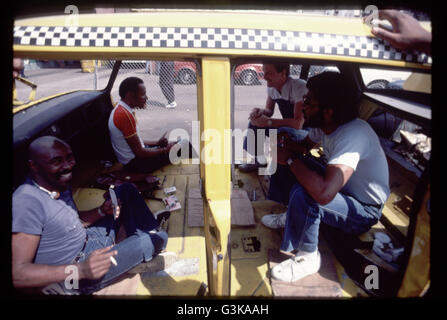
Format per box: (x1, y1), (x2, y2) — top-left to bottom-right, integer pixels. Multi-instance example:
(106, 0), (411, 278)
(108, 77), (176, 173)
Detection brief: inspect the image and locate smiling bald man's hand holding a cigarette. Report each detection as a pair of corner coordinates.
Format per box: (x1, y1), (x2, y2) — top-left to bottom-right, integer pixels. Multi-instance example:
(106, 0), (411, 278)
(79, 246), (118, 279)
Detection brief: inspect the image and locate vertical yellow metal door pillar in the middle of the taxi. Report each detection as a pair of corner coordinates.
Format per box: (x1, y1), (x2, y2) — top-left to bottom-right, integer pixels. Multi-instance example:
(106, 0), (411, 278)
(197, 57), (231, 295)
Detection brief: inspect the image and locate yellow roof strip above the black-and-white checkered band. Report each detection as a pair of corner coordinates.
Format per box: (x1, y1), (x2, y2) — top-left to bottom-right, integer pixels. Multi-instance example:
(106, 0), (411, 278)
(15, 10), (430, 36)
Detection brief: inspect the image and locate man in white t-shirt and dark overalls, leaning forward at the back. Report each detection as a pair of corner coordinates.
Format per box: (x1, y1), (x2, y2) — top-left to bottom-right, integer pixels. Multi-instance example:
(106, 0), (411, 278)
(239, 63), (307, 172)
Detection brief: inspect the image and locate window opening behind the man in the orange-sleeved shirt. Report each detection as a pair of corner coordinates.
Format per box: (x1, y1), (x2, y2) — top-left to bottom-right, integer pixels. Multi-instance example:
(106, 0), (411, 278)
(111, 60), (197, 141)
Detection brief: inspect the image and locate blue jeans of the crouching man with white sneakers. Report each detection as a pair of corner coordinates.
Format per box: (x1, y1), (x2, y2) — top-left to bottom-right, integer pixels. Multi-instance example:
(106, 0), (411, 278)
(268, 132), (382, 252)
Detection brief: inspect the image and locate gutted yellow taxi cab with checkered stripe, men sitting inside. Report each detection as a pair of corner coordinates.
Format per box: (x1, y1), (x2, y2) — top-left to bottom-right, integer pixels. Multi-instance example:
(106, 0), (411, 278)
(12, 10), (432, 297)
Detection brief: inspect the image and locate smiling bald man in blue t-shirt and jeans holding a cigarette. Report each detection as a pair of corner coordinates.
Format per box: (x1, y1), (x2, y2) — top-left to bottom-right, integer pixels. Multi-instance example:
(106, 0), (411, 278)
(12, 136), (172, 294)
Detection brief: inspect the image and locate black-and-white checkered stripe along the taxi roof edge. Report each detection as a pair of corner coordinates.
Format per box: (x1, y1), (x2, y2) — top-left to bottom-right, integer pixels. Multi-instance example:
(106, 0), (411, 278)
(14, 26), (432, 64)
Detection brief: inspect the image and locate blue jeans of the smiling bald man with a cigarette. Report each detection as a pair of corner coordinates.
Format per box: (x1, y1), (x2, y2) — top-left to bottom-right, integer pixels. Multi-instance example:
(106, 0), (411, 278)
(72, 183), (168, 294)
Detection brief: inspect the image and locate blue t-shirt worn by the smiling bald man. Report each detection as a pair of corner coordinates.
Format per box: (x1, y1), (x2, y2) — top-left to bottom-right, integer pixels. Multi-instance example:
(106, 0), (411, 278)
(12, 179), (86, 265)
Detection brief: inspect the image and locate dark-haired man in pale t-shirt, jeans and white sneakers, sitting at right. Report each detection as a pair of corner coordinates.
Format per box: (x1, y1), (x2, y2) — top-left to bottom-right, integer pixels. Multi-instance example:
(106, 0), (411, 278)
(261, 72), (390, 281)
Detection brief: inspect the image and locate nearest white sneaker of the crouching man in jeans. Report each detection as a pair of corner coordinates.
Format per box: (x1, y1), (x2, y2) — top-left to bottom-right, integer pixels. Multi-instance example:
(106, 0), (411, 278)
(271, 250), (321, 282)
